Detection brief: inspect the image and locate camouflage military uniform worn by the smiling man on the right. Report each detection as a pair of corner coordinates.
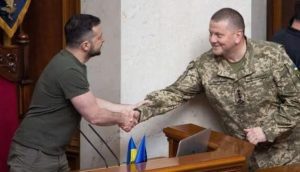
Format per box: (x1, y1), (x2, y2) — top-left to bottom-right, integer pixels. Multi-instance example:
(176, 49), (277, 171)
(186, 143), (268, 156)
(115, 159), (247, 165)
(139, 39), (300, 167)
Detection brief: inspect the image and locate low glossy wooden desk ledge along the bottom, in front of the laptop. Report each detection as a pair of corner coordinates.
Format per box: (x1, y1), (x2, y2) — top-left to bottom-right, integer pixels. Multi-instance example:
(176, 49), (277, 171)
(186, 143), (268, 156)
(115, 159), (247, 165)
(80, 154), (246, 172)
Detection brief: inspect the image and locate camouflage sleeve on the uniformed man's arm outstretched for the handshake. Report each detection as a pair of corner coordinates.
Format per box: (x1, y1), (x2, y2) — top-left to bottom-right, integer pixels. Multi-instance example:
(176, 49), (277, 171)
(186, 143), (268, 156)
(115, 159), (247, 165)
(138, 61), (202, 122)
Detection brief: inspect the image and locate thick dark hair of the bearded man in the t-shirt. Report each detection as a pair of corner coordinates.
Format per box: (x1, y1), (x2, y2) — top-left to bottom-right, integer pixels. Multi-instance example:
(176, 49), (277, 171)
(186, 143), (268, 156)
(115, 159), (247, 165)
(64, 14), (101, 47)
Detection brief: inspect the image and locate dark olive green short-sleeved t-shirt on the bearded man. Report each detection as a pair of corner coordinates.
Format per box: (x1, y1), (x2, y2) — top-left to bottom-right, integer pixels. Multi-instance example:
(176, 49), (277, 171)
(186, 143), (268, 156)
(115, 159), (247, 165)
(13, 50), (89, 155)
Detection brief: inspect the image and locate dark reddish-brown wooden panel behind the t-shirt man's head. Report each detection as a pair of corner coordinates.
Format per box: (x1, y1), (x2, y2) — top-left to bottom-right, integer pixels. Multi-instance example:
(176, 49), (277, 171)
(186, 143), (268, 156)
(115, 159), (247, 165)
(23, 0), (80, 95)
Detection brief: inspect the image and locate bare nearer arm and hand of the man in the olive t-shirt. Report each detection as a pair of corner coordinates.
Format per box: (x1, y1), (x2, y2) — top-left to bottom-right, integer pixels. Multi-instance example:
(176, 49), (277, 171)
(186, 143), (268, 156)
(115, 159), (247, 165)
(71, 91), (138, 132)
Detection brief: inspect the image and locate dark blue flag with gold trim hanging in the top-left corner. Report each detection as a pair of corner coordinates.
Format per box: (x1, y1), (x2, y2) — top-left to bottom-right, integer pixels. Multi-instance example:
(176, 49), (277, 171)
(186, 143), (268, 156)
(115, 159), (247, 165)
(0, 0), (31, 38)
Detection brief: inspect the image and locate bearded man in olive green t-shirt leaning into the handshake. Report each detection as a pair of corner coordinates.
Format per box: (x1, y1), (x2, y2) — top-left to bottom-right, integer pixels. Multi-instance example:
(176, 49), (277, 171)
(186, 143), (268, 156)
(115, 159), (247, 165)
(8, 14), (138, 172)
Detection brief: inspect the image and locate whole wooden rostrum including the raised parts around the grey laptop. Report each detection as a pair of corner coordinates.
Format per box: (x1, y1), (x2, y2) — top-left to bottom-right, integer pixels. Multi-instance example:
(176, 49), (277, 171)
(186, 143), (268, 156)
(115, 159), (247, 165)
(77, 124), (254, 172)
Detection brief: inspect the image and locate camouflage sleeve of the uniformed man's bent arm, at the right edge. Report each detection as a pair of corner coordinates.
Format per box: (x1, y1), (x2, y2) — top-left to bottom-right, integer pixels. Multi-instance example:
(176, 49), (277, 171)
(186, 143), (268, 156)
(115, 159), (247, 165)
(262, 48), (300, 142)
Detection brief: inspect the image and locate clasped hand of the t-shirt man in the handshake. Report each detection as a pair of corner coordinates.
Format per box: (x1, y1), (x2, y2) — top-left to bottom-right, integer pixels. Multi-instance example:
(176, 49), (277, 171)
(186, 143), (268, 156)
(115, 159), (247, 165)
(119, 110), (139, 132)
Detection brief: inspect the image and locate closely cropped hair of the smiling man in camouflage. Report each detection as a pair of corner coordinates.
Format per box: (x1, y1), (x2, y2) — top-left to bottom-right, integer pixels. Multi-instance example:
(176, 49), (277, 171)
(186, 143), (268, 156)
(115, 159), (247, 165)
(211, 8), (245, 32)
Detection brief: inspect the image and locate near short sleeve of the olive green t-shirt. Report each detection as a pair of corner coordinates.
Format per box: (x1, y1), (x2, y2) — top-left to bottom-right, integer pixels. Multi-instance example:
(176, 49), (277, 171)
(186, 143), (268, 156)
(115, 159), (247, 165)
(58, 68), (89, 99)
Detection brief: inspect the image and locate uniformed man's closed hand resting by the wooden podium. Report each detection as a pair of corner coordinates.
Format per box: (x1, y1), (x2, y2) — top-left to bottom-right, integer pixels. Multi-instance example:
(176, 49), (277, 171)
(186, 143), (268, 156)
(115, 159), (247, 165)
(244, 127), (267, 145)
